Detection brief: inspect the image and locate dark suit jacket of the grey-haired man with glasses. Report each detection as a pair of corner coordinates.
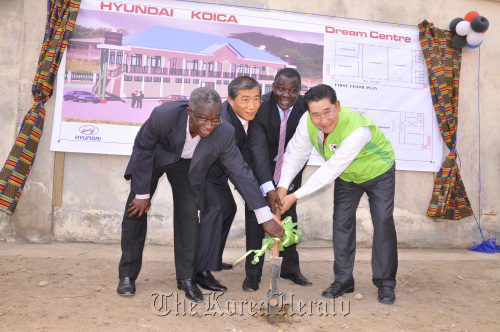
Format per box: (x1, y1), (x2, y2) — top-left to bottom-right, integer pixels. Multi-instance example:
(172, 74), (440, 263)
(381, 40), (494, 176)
(125, 101), (267, 210)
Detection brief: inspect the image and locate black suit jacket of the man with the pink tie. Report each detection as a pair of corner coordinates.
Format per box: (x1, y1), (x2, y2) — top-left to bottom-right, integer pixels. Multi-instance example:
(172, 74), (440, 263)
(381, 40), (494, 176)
(248, 92), (307, 189)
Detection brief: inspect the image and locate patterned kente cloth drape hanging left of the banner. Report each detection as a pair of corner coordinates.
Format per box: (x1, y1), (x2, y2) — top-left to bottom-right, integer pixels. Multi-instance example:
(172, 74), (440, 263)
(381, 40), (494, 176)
(0, 0), (81, 215)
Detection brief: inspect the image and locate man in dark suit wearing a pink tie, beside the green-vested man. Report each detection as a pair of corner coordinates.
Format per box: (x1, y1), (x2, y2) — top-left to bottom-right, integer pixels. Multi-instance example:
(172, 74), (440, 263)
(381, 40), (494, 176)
(242, 68), (312, 291)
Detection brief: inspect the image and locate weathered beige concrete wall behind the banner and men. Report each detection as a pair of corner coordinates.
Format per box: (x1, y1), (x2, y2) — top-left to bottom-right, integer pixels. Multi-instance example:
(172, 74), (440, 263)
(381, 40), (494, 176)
(0, 0), (500, 248)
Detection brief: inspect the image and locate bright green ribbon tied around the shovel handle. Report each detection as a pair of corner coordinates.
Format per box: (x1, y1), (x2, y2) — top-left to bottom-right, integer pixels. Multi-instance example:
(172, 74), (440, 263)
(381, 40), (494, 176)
(233, 217), (304, 266)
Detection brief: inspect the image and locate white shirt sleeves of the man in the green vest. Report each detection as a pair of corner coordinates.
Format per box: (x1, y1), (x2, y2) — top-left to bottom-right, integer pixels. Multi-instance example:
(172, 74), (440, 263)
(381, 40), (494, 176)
(278, 112), (372, 199)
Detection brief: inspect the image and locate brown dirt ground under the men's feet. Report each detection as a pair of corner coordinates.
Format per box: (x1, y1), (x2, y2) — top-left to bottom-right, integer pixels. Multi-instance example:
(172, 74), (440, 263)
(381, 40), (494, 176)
(0, 243), (500, 331)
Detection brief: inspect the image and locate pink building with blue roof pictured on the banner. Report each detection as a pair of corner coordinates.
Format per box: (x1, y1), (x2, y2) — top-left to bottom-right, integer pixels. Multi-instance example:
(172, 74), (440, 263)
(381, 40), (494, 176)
(68, 26), (290, 100)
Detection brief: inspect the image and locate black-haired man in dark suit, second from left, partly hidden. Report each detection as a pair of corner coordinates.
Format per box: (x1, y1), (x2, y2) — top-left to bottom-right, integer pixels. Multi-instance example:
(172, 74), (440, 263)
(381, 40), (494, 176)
(196, 76), (261, 291)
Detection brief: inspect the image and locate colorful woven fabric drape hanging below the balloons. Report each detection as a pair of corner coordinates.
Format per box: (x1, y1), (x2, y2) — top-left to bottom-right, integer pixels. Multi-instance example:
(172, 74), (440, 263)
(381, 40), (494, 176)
(418, 21), (474, 220)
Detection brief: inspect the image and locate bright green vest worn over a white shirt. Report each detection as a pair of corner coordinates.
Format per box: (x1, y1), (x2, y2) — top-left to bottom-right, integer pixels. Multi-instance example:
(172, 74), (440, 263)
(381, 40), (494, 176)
(307, 107), (394, 183)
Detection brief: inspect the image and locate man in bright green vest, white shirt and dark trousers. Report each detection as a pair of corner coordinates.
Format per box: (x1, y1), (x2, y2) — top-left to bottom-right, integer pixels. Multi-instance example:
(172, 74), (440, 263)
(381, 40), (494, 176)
(278, 84), (398, 304)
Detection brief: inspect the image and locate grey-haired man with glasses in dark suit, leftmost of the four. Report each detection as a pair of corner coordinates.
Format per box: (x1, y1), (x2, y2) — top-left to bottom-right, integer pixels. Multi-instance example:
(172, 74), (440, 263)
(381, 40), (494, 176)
(117, 88), (283, 302)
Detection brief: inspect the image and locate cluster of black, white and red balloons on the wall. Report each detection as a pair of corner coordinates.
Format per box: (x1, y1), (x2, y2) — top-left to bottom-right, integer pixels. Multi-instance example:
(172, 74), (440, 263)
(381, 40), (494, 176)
(450, 11), (490, 49)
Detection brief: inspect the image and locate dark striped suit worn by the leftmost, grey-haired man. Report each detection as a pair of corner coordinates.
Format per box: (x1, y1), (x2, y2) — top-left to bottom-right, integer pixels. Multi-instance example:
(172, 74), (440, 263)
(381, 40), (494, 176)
(119, 102), (266, 279)
